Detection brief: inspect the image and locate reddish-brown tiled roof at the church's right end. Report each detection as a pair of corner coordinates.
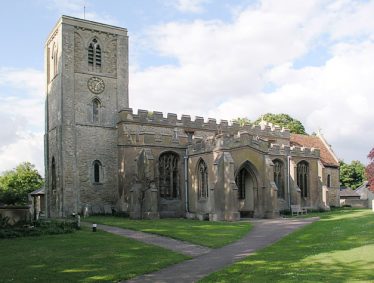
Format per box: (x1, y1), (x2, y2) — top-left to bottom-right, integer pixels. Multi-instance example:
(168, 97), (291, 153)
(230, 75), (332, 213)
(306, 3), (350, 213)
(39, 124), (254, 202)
(290, 134), (339, 167)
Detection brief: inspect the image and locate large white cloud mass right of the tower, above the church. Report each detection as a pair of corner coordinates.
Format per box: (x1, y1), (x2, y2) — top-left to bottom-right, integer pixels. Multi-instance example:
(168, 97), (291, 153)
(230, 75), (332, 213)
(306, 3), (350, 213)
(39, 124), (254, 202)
(130, 0), (374, 164)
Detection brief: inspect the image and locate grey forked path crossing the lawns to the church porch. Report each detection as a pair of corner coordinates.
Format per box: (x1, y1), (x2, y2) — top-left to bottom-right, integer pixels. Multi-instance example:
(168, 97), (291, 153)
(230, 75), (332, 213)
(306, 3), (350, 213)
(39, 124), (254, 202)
(87, 217), (319, 283)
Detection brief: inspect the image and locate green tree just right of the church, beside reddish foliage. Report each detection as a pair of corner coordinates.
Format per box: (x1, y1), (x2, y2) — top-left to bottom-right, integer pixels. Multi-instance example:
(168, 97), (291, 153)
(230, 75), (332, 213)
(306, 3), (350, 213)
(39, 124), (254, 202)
(339, 160), (365, 189)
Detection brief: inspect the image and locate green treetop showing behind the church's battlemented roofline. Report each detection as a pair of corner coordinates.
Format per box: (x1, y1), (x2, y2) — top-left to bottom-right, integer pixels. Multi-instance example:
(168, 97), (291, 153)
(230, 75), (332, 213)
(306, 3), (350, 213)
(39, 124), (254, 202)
(255, 113), (307, 135)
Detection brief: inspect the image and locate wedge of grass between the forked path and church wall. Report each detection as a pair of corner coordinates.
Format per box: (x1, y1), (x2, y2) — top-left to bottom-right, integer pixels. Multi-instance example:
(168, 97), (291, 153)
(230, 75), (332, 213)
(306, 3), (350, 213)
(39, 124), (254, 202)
(84, 216), (251, 248)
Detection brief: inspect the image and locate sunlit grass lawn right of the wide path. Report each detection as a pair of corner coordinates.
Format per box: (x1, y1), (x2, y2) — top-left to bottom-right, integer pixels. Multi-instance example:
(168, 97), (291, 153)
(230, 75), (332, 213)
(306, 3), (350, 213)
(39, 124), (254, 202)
(201, 209), (374, 283)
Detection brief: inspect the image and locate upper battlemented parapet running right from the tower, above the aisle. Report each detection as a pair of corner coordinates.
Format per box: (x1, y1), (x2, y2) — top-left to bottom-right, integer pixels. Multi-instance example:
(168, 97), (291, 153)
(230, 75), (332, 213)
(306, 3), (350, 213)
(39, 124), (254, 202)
(118, 108), (290, 139)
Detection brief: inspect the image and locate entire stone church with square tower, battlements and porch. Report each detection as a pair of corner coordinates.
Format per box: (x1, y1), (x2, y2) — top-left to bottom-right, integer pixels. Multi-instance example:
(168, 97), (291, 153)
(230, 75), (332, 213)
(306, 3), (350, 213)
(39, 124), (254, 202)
(45, 16), (339, 220)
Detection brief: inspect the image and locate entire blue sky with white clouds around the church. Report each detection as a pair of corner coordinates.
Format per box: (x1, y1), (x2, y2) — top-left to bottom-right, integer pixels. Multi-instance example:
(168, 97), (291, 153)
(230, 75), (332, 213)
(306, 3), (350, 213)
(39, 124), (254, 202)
(0, 0), (374, 174)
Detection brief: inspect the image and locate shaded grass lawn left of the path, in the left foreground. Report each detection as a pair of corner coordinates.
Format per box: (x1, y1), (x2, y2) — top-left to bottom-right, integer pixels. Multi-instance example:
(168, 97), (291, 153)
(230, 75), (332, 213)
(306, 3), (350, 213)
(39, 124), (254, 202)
(0, 229), (188, 282)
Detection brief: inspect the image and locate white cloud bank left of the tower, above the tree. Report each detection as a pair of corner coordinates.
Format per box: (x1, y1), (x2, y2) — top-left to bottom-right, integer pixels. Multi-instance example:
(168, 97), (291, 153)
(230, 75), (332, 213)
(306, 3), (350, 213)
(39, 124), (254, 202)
(0, 68), (45, 173)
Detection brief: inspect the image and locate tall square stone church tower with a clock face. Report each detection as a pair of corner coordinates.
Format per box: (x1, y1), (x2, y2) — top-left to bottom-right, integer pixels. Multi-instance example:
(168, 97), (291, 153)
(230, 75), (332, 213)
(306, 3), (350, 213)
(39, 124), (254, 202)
(45, 16), (129, 217)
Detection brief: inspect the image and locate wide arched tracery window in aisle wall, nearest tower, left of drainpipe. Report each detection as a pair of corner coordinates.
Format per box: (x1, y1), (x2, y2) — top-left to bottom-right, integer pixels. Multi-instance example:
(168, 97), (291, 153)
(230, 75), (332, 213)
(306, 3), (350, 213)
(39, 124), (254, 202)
(158, 152), (179, 199)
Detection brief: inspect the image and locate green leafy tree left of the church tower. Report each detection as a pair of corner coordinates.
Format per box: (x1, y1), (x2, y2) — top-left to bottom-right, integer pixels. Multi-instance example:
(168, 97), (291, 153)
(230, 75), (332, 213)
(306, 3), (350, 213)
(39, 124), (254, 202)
(0, 162), (44, 205)
